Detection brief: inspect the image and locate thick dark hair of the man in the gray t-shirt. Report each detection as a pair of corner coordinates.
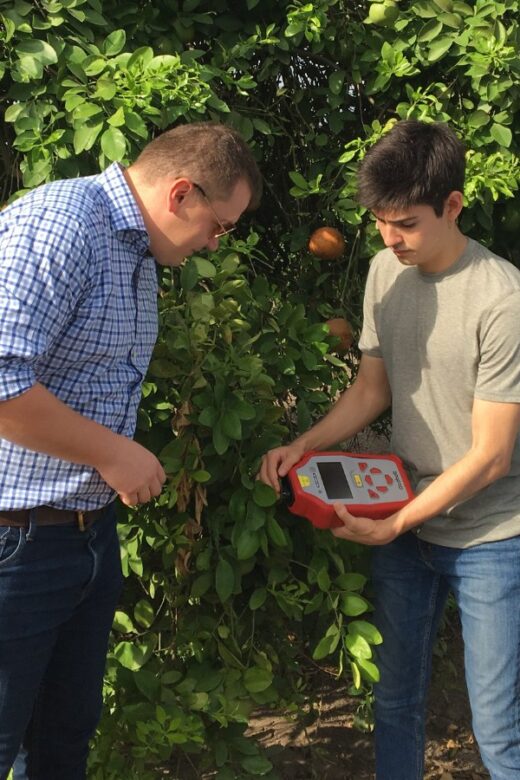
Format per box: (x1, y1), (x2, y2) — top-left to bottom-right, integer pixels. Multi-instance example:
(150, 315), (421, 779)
(358, 119), (465, 217)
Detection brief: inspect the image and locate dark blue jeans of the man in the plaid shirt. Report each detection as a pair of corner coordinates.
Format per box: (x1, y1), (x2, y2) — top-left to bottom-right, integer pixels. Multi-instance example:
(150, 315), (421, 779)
(0, 507), (122, 780)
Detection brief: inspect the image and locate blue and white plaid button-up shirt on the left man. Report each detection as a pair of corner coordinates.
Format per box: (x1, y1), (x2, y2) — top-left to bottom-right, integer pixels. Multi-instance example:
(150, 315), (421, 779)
(0, 164), (157, 510)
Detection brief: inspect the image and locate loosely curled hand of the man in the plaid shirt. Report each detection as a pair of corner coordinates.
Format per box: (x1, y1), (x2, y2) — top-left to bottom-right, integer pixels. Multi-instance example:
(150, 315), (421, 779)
(96, 435), (166, 506)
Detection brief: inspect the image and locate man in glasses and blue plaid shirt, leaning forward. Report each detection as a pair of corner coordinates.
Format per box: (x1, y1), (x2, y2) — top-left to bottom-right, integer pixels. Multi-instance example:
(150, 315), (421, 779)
(0, 123), (261, 780)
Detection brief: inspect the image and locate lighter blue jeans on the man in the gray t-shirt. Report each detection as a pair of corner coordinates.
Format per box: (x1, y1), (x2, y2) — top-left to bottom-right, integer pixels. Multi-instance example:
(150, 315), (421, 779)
(373, 533), (520, 780)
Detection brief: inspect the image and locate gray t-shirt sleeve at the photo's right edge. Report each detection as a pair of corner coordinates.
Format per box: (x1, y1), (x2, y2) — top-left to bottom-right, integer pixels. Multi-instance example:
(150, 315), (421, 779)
(475, 290), (520, 403)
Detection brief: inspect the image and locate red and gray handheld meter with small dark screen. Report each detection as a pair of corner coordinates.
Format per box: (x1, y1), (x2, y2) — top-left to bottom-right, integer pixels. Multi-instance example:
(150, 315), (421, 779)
(282, 451), (414, 528)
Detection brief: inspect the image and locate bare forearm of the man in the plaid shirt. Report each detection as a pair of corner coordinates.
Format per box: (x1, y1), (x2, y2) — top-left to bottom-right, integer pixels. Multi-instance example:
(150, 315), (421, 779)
(0, 384), (123, 468)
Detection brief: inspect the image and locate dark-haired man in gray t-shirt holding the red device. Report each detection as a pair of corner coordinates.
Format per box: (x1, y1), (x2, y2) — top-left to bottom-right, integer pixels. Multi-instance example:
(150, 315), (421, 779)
(260, 120), (520, 780)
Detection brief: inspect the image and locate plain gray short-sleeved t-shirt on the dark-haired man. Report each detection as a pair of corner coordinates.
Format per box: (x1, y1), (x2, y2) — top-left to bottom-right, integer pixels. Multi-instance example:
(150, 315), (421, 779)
(359, 239), (520, 548)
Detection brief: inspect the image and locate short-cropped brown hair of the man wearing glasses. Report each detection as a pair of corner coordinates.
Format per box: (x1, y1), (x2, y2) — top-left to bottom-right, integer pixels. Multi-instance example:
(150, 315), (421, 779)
(134, 122), (262, 210)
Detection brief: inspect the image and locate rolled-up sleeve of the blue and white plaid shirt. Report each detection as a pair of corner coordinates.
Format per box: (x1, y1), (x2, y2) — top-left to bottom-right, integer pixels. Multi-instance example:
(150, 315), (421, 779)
(0, 210), (89, 401)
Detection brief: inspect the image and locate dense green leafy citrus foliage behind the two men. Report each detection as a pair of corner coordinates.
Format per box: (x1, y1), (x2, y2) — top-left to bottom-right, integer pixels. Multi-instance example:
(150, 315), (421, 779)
(0, 0), (520, 780)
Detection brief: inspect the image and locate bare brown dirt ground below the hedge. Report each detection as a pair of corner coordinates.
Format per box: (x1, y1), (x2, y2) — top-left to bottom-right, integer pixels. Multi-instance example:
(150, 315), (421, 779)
(245, 617), (489, 780)
